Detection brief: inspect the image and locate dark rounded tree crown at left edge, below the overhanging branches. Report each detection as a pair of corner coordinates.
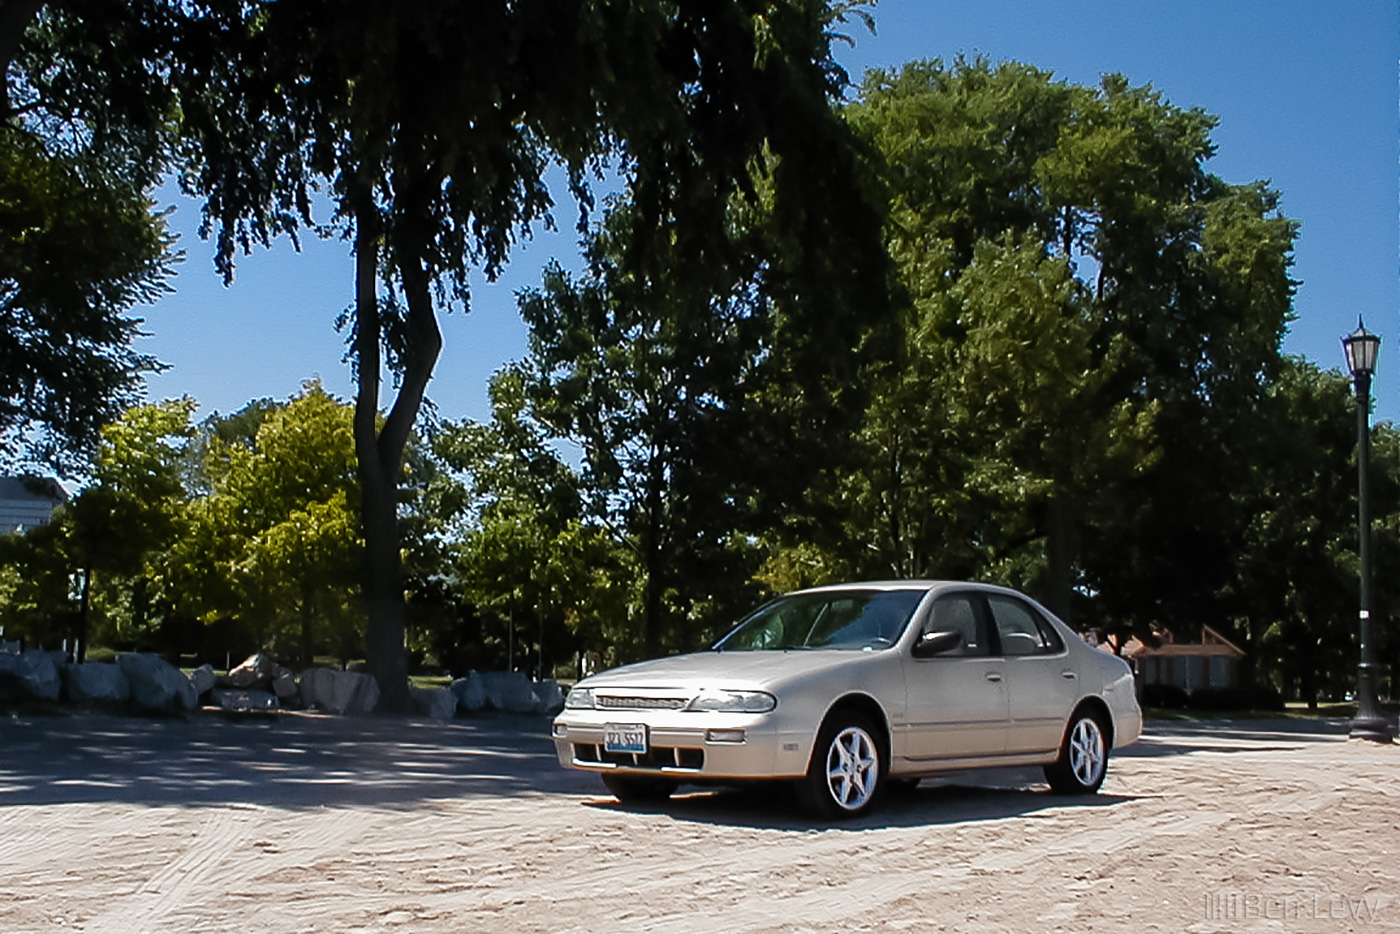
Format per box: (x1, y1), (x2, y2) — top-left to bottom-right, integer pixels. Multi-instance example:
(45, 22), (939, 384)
(0, 110), (174, 472)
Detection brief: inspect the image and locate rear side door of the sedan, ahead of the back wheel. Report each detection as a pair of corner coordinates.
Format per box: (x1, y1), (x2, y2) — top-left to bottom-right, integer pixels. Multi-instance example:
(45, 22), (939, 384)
(987, 594), (1081, 753)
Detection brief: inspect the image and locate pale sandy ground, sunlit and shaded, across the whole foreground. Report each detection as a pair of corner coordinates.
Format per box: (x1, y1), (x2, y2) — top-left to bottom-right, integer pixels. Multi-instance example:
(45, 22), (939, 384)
(0, 716), (1400, 934)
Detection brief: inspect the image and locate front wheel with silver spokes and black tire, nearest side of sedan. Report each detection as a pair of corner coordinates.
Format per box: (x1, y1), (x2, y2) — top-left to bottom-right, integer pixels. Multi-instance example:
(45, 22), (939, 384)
(797, 710), (889, 819)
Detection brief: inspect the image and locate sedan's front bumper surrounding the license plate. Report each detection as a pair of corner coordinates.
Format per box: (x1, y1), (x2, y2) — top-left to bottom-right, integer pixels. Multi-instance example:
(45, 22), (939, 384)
(553, 710), (812, 781)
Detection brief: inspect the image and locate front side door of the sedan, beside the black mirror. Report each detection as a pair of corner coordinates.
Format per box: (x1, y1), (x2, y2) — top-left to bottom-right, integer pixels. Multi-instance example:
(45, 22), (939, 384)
(904, 591), (1008, 762)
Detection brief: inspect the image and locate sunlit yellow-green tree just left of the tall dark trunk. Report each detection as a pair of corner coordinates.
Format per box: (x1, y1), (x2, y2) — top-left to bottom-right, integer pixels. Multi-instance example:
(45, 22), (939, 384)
(161, 382), (363, 664)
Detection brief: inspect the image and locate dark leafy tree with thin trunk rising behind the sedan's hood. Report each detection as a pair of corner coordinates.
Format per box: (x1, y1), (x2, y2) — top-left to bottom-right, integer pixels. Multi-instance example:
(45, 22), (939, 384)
(521, 204), (772, 657)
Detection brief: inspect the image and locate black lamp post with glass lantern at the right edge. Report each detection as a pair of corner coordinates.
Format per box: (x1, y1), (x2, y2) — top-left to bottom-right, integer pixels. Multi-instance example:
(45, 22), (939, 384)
(1341, 319), (1390, 742)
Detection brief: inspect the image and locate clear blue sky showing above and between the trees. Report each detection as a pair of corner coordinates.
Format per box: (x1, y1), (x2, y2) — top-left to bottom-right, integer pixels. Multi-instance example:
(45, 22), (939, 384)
(139, 0), (1400, 420)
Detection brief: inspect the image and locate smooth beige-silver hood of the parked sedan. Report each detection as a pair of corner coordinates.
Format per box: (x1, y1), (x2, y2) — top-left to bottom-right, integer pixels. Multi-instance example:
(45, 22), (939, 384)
(578, 648), (895, 690)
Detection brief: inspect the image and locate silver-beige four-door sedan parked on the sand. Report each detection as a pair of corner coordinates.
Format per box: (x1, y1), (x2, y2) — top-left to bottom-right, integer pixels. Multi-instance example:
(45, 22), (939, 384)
(553, 581), (1142, 816)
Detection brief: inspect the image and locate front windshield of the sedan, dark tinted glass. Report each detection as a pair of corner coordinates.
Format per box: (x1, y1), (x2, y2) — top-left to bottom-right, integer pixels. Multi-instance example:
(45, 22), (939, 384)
(714, 590), (924, 651)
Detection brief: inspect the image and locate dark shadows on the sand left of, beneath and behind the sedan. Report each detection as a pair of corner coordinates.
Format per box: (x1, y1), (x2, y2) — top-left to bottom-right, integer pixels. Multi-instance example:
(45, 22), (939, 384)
(0, 711), (1347, 830)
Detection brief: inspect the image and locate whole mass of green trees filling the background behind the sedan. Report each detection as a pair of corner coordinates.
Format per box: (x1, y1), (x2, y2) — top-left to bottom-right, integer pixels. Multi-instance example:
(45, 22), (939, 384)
(0, 9), (1400, 706)
